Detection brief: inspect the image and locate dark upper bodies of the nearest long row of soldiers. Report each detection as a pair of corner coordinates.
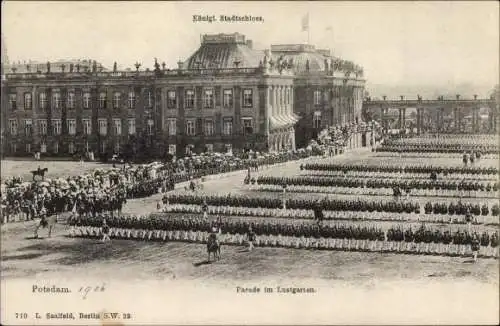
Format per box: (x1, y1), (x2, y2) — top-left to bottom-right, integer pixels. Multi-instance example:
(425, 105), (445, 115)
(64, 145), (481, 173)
(69, 215), (498, 247)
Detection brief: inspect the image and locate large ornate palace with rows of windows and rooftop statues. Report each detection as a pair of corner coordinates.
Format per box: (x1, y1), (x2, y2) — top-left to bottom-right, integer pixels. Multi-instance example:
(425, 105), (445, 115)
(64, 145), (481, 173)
(2, 33), (364, 157)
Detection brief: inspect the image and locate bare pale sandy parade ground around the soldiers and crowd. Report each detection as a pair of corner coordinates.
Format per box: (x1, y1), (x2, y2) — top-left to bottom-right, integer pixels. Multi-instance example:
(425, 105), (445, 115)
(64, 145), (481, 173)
(1, 151), (499, 289)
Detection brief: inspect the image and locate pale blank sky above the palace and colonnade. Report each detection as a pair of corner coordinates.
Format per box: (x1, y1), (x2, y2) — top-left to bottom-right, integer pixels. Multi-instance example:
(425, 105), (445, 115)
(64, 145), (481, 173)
(1, 1), (500, 96)
